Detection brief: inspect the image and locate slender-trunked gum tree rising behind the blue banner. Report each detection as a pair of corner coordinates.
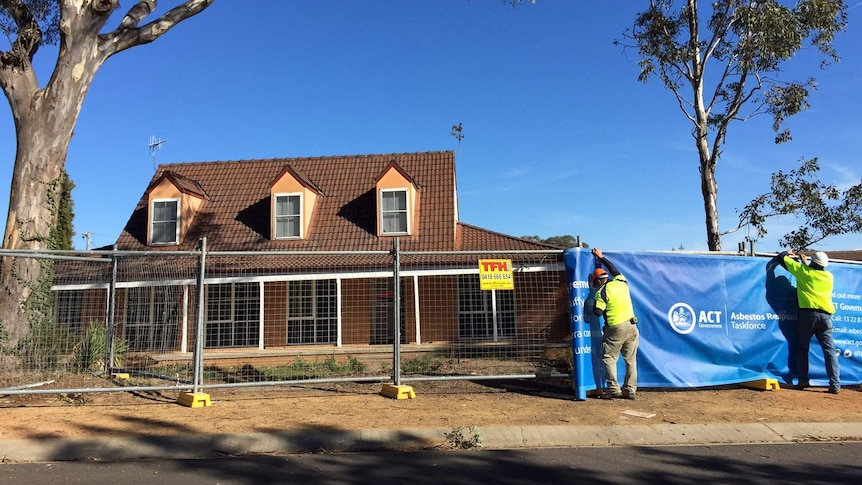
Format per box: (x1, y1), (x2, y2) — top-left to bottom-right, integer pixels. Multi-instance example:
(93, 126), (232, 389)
(621, 0), (847, 251)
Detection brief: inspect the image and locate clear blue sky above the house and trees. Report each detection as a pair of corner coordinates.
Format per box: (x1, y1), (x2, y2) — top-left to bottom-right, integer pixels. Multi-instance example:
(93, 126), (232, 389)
(0, 0), (862, 251)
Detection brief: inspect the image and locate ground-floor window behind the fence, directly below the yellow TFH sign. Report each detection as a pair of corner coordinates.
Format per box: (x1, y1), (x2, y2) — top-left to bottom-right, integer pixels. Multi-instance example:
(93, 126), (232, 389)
(458, 274), (515, 340)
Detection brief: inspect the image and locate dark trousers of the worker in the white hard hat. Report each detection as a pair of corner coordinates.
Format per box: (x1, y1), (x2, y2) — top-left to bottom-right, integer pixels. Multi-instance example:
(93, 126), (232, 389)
(796, 308), (841, 389)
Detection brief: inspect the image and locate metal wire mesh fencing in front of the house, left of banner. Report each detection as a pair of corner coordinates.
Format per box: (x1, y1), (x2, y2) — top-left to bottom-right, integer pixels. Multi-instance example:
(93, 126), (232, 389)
(0, 240), (571, 395)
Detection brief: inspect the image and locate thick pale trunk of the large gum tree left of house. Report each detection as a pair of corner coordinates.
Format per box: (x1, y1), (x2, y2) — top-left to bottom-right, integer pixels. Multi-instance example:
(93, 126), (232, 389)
(0, 15), (104, 355)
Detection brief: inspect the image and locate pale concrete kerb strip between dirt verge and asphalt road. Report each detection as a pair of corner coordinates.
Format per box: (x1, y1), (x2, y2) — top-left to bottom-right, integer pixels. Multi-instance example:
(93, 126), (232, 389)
(0, 423), (862, 462)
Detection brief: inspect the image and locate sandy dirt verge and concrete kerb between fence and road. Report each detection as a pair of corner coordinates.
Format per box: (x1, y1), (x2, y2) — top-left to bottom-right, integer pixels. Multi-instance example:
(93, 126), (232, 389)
(5, 381), (862, 463)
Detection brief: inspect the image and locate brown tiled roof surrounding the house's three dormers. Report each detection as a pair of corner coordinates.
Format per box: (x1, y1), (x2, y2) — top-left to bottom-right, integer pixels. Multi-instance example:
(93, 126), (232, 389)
(117, 151), (559, 251)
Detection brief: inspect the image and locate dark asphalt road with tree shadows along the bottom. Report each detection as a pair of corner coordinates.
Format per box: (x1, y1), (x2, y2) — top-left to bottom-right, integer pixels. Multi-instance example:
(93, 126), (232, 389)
(0, 442), (862, 485)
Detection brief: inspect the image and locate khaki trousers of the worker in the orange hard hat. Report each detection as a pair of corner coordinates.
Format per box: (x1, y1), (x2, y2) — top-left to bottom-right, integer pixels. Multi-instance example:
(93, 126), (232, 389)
(602, 322), (640, 394)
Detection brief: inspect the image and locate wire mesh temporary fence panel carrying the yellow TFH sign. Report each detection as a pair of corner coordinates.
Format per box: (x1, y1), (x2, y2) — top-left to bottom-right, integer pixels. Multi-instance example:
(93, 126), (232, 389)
(400, 251), (570, 381)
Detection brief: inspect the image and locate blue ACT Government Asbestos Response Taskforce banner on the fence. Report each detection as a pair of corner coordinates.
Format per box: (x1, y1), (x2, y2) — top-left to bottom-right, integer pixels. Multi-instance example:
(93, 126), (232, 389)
(564, 248), (862, 399)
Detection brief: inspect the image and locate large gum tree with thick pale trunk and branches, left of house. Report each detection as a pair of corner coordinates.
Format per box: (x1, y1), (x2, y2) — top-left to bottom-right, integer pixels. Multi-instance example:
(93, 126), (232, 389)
(0, 0), (214, 351)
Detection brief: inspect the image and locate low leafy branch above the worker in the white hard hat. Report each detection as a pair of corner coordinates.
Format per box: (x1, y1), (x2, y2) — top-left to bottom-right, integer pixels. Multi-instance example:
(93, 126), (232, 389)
(739, 158), (862, 249)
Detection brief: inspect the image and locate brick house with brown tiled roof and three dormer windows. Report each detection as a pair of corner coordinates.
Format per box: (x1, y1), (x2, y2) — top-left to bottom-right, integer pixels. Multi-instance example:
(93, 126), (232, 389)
(55, 151), (569, 358)
